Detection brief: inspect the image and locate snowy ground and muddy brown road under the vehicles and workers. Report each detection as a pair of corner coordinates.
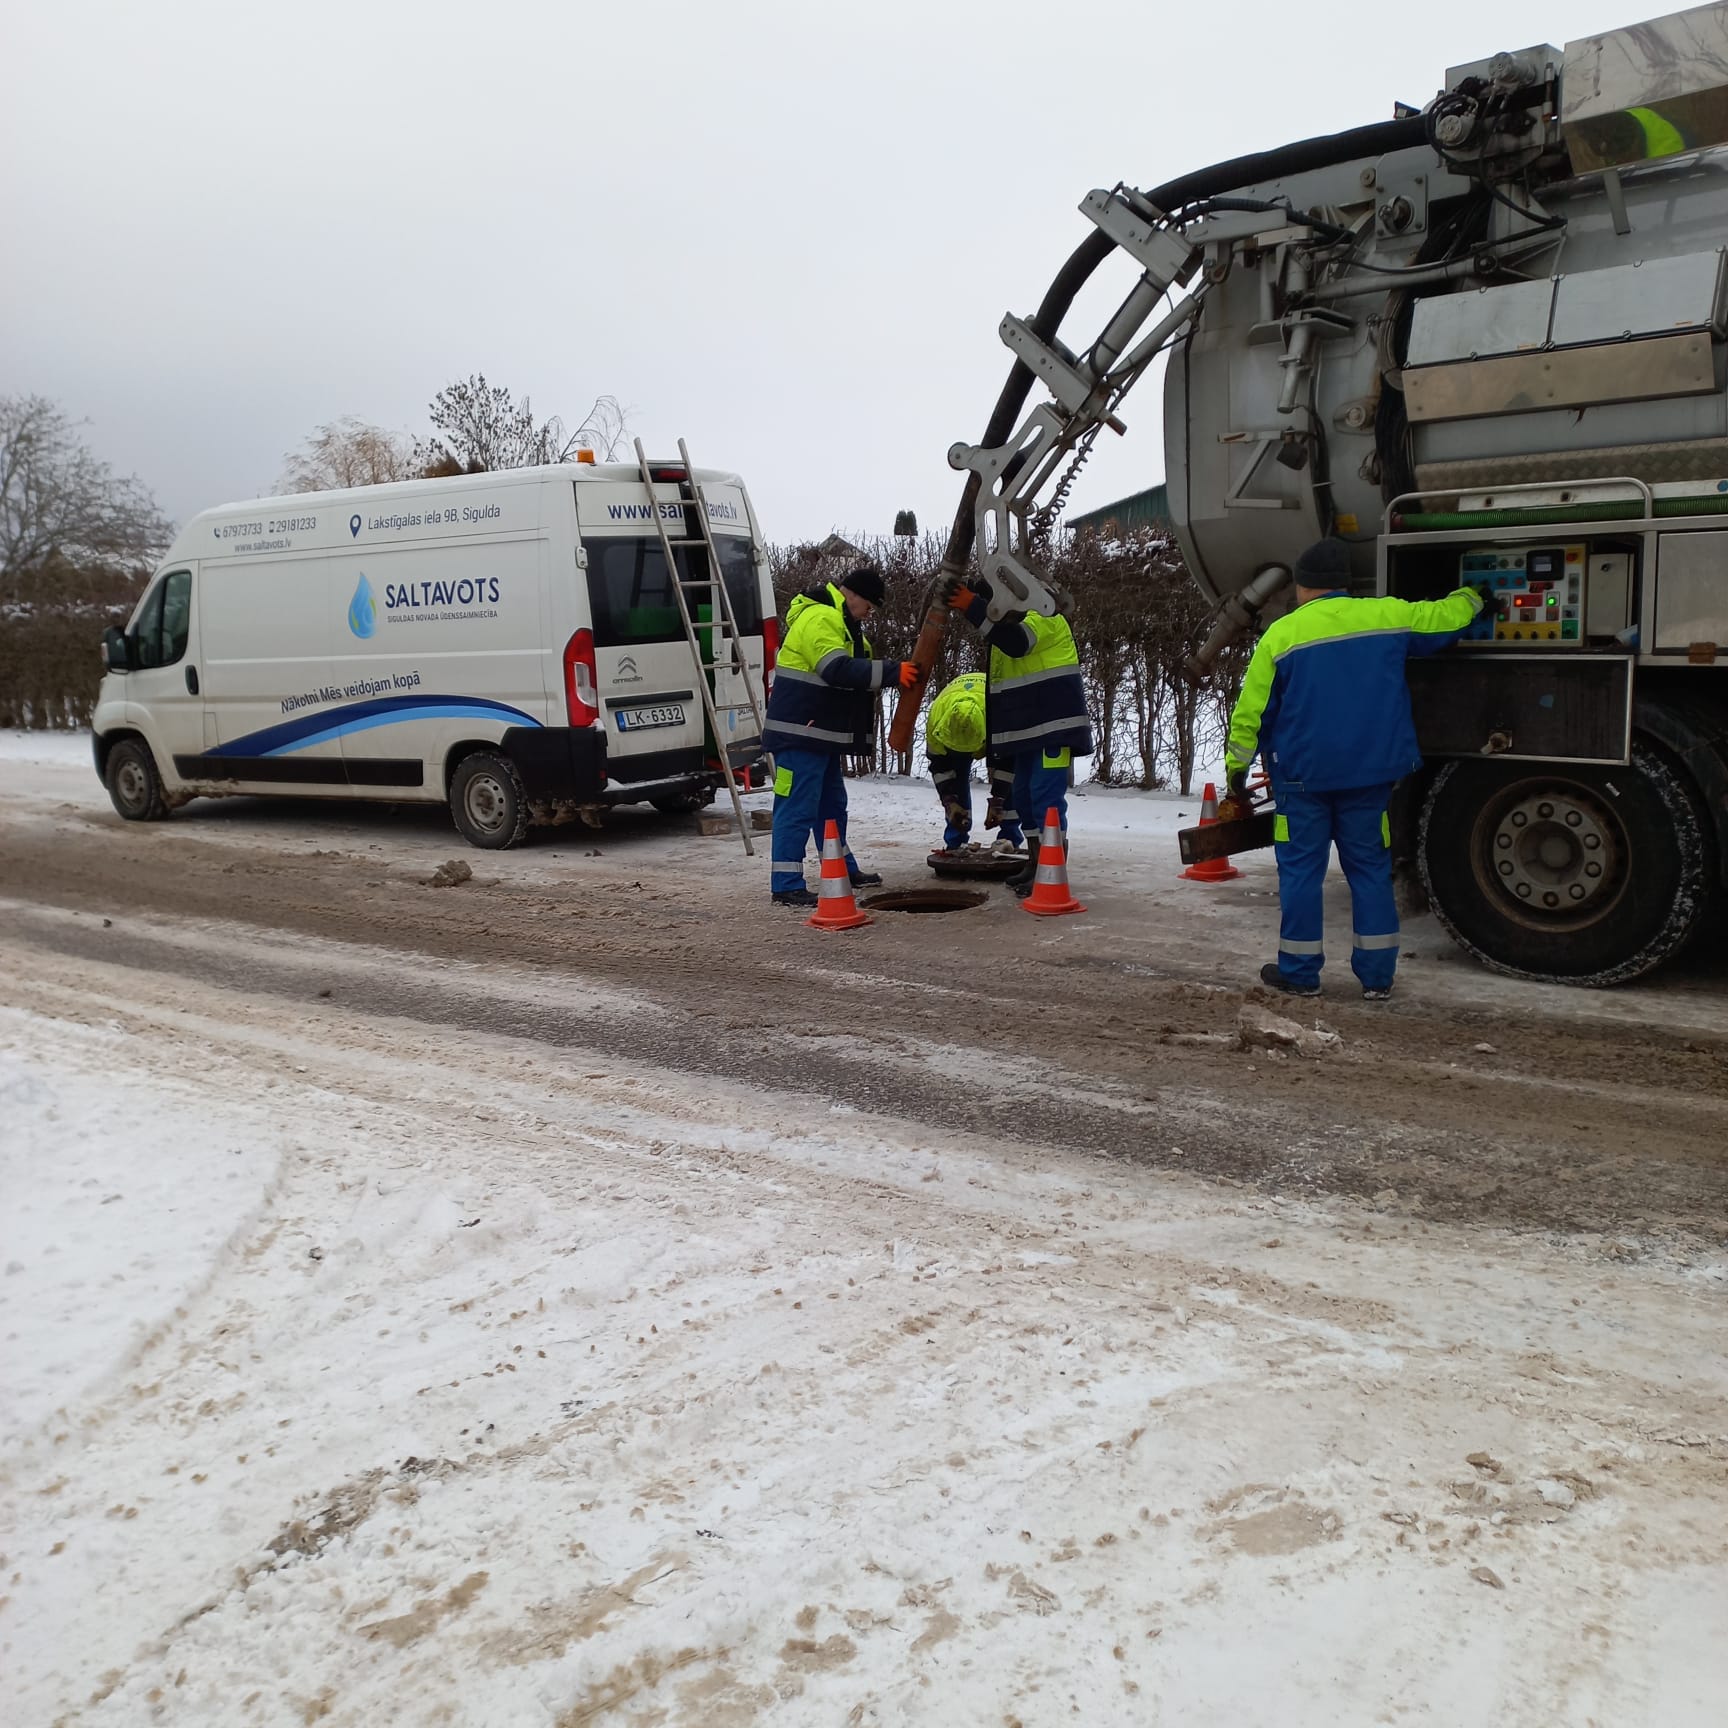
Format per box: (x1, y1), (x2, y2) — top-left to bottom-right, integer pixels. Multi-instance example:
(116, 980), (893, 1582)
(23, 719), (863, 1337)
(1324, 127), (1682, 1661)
(0, 736), (1728, 1728)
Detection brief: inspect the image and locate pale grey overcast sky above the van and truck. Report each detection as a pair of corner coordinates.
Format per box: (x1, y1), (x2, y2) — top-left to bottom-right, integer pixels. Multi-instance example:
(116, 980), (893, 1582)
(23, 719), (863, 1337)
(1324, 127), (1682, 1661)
(0, 0), (1617, 541)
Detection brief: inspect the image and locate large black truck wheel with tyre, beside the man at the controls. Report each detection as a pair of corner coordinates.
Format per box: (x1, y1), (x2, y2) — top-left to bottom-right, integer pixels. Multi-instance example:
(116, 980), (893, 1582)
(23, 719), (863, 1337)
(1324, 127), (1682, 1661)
(1417, 743), (1712, 985)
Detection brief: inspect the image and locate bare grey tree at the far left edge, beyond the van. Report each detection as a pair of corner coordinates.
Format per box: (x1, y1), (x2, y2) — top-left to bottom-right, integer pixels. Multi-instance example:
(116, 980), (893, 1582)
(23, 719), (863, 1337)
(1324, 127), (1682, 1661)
(0, 396), (173, 591)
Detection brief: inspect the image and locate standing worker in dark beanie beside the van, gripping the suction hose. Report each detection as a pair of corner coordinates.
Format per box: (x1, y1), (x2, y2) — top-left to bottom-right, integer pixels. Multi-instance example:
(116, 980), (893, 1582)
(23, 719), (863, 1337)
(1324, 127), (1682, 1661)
(762, 565), (918, 905)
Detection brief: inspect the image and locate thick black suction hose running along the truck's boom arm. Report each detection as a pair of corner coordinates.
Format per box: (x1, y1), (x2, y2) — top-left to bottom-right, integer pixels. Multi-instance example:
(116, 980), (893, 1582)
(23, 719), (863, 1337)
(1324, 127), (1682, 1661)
(942, 116), (1427, 575)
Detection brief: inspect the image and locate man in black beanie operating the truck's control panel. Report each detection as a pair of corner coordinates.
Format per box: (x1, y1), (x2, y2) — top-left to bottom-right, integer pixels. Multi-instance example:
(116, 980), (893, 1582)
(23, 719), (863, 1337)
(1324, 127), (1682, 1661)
(1225, 539), (1483, 1002)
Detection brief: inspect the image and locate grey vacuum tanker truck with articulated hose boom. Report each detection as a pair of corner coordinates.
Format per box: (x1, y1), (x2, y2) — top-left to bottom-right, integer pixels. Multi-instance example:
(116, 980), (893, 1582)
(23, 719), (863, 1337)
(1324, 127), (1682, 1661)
(945, 5), (1728, 985)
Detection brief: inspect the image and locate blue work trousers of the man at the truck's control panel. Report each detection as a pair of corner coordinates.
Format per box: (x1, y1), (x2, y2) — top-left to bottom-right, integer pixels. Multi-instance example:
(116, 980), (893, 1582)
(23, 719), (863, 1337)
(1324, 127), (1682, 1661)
(1274, 785), (1398, 990)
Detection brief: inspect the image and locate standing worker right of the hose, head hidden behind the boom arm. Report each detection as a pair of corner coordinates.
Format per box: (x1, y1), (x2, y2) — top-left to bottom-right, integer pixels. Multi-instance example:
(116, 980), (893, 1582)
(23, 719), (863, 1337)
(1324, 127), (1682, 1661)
(942, 577), (1092, 899)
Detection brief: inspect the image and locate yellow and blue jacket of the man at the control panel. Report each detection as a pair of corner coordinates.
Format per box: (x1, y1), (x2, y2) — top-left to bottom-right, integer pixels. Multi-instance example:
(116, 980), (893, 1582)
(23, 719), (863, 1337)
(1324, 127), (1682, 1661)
(1223, 588), (1483, 791)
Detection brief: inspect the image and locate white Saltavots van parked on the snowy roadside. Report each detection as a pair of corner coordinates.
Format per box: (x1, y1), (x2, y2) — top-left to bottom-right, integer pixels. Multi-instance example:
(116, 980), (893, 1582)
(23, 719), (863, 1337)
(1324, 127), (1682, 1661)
(92, 461), (778, 847)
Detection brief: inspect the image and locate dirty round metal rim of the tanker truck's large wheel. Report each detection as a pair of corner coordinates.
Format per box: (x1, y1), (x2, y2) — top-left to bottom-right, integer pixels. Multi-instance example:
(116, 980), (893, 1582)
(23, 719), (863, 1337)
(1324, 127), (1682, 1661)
(1483, 786), (1628, 928)
